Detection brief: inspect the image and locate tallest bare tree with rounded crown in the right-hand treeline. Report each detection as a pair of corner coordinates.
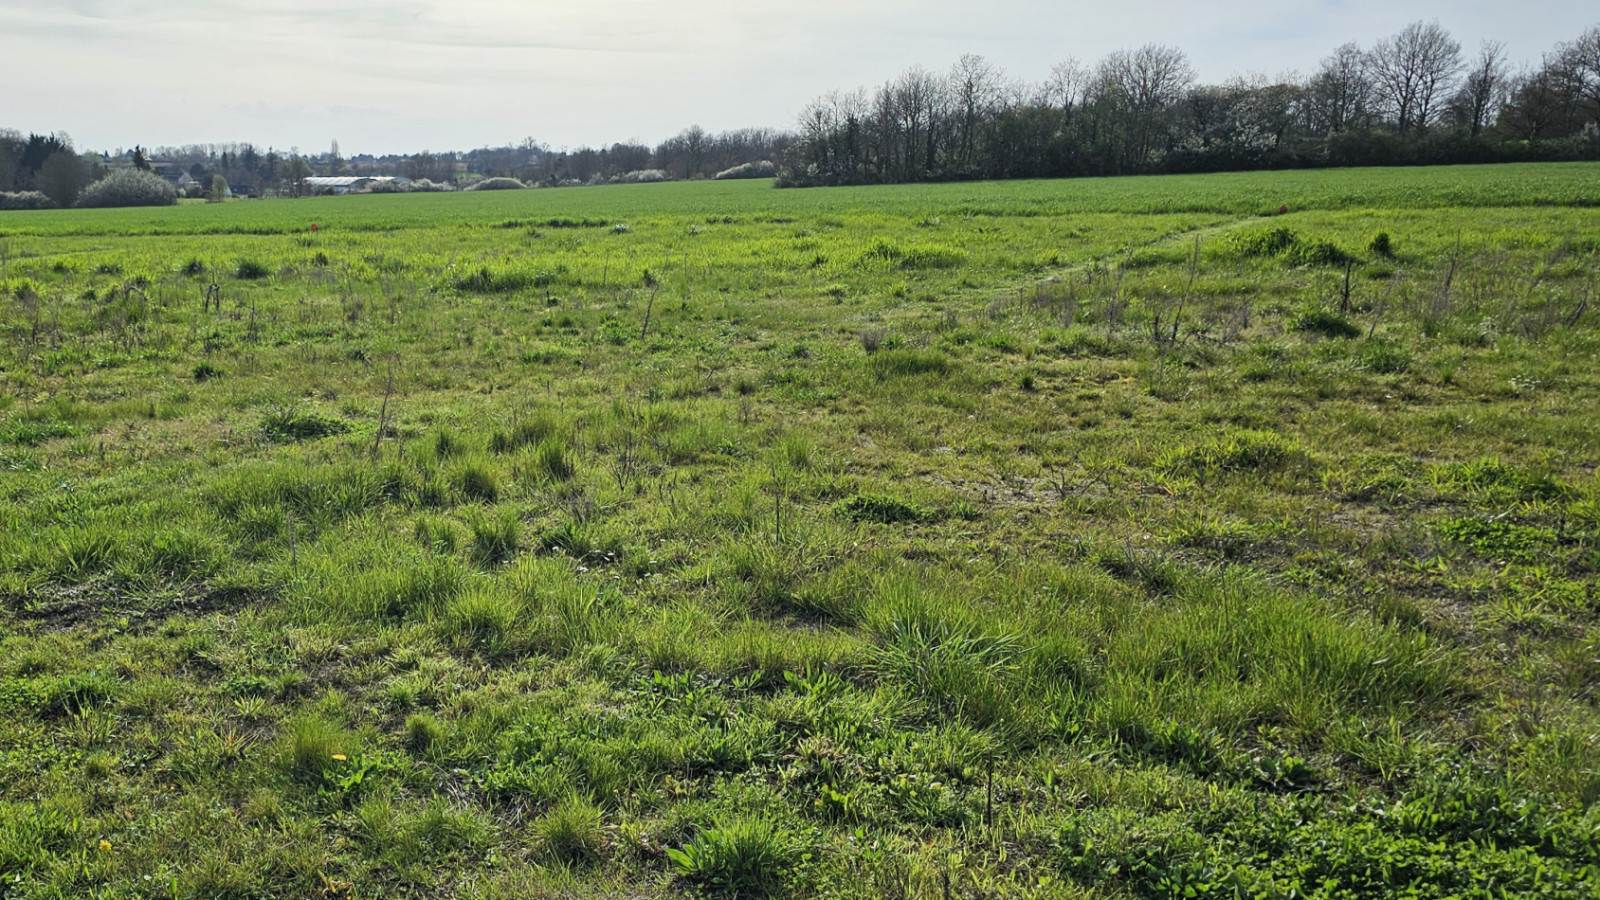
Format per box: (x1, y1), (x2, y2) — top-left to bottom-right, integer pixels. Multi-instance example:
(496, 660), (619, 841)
(1368, 21), (1461, 133)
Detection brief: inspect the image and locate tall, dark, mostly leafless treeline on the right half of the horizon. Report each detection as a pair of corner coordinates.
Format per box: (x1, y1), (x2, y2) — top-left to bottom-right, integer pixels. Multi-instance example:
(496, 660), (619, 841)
(781, 22), (1600, 186)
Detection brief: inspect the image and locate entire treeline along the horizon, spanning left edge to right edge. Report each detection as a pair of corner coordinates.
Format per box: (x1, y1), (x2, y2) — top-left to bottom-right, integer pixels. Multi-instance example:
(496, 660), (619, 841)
(0, 22), (1600, 208)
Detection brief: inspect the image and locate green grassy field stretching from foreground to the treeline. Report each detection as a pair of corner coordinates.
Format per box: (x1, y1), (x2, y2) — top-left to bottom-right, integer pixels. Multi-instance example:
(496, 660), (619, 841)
(0, 163), (1600, 900)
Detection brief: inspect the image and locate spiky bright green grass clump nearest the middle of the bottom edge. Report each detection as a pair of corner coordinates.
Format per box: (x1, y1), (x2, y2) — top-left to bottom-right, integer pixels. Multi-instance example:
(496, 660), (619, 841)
(667, 818), (798, 897)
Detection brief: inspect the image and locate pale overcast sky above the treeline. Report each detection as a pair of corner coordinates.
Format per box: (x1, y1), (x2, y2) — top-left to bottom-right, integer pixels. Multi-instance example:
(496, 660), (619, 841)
(0, 0), (1600, 155)
